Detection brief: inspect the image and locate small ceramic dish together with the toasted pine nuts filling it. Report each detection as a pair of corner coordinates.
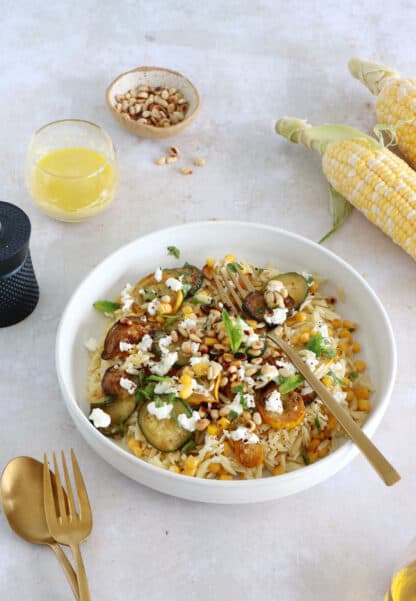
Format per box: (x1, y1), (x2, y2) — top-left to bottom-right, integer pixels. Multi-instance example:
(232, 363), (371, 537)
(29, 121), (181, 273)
(106, 67), (200, 139)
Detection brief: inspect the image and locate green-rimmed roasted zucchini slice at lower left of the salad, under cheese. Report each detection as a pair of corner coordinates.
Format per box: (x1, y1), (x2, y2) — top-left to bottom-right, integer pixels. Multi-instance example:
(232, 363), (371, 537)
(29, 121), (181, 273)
(139, 399), (192, 453)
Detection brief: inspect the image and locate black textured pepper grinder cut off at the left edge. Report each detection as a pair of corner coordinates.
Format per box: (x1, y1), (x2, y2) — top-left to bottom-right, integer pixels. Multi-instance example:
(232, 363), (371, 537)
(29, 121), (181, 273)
(0, 201), (39, 328)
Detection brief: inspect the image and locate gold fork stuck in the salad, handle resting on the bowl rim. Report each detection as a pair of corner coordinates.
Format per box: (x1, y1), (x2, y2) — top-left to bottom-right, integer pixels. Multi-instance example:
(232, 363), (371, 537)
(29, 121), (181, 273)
(214, 268), (400, 486)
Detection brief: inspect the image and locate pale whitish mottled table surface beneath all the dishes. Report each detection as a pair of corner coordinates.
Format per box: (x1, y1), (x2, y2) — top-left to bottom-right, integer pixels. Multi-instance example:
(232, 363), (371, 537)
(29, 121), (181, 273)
(0, 0), (416, 601)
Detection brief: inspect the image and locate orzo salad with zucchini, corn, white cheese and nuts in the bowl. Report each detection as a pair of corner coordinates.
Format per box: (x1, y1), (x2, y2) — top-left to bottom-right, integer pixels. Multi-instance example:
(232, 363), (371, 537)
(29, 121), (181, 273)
(86, 247), (371, 480)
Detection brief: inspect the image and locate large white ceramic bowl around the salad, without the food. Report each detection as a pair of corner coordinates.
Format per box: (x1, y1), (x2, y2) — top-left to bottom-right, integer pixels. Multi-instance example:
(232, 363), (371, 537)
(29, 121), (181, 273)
(56, 221), (396, 503)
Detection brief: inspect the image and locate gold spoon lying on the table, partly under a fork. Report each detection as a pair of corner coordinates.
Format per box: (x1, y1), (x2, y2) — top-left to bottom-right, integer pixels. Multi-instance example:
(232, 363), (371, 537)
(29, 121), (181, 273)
(0, 457), (79, 600)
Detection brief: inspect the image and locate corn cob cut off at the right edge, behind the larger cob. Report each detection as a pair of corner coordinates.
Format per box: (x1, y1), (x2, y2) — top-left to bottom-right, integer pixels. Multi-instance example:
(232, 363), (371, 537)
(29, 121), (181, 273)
(348, 58), (416, 168)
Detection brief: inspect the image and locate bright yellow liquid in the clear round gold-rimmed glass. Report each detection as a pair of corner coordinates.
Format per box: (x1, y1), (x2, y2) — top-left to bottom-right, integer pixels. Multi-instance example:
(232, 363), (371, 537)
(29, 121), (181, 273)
(30, 147), (117, 221)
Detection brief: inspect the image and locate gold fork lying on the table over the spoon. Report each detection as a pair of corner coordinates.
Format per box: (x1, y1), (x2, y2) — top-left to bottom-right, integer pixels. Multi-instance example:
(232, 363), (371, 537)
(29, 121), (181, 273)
(43, 449), (92, 601)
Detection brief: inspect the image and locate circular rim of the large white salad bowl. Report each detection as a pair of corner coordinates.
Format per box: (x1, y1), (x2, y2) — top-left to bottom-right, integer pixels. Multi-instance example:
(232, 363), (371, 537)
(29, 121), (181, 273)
(55, 220), (397, 490)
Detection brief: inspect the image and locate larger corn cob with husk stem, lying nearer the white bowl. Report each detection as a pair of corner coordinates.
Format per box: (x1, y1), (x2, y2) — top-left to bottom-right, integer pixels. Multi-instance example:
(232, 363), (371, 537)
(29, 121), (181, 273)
(276, 117), (416, 259)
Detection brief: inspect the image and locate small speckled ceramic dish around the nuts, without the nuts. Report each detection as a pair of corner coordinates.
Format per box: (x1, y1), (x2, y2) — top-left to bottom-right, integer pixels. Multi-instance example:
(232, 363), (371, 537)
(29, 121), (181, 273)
(105, 67), (201, 139)
